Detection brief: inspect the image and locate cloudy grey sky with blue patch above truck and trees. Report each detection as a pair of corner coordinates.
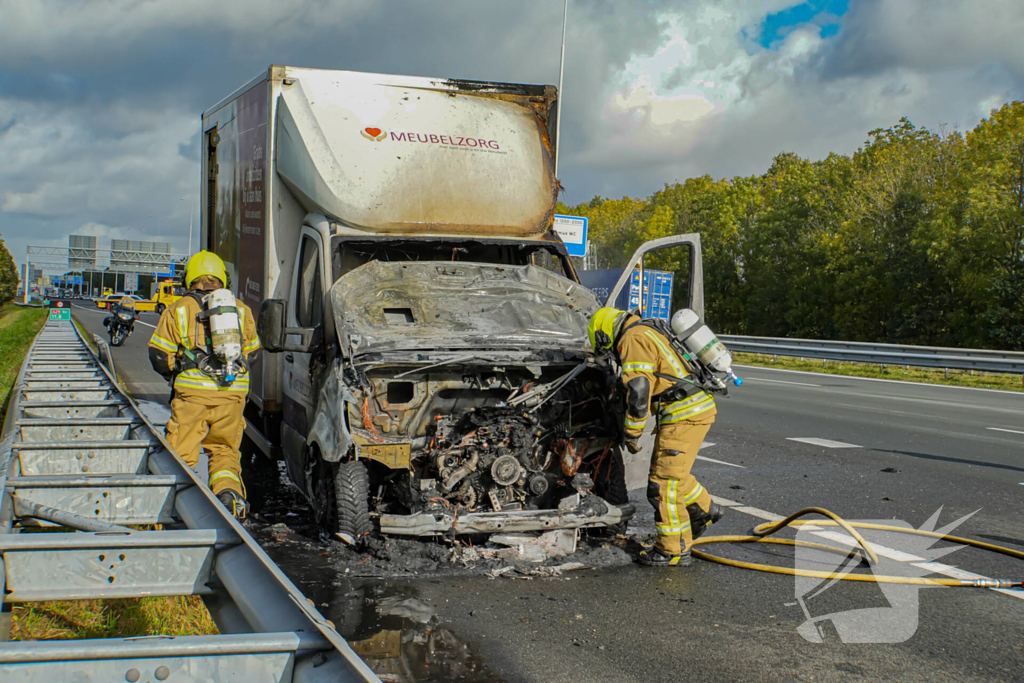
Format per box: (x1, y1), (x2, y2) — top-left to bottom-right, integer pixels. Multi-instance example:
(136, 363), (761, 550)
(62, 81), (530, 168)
(0, 0), (1024, 272)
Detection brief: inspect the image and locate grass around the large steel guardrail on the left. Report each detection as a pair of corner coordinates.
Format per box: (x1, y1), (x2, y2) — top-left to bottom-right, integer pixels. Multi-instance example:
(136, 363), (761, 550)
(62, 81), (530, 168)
(0, 305), (217, 640)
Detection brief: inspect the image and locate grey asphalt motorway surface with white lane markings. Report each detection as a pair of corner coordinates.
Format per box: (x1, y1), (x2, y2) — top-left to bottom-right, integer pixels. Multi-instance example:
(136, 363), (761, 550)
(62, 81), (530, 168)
(75, 309), (1024, 683)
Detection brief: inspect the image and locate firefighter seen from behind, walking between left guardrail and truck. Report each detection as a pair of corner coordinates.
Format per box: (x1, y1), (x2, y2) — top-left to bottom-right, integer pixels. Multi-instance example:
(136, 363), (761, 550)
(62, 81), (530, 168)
(150, 251), (259, 519)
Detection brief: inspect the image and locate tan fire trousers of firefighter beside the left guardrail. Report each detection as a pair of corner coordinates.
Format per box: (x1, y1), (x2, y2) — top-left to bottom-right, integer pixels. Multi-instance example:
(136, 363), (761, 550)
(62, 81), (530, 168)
(165, 394), (246, 497)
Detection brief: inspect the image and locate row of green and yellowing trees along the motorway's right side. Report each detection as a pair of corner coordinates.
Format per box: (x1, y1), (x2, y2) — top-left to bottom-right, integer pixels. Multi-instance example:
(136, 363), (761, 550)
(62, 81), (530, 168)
(559, 102), (1024, 350)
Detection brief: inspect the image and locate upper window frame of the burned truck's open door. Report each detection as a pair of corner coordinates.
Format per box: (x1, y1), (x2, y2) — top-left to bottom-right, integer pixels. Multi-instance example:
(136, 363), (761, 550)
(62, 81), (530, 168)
(604, 232), (703, 319)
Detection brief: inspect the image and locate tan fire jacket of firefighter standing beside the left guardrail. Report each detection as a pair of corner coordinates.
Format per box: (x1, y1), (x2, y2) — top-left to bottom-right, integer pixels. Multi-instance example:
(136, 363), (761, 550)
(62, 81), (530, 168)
(150, 296), (259, 402)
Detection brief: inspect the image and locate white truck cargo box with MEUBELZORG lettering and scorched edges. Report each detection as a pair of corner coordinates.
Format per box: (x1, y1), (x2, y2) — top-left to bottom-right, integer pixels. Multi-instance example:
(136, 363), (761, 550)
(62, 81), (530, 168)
(201, 66), (557, 412)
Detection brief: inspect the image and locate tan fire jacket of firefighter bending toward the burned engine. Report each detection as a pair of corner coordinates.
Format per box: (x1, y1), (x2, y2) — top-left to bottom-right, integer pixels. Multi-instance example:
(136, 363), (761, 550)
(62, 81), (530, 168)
(615, 315), (717, 438)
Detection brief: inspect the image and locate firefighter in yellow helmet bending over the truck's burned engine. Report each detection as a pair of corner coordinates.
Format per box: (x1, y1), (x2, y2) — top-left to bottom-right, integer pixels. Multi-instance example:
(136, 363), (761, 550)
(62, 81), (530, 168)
(588, 308), (724, 566)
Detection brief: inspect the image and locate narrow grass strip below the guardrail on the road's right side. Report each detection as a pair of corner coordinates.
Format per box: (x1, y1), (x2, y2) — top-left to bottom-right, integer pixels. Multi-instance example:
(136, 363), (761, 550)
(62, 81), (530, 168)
(734, 353), (1024, 391)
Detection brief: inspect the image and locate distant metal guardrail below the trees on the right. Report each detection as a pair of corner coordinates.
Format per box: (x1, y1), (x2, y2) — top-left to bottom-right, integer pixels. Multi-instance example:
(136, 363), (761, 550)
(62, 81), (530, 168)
(719, 335), (1024, 375)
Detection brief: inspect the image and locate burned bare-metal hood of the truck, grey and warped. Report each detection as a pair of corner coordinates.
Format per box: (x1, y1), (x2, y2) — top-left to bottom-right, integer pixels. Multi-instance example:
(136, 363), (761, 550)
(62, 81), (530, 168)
(331, 261), (598, 353)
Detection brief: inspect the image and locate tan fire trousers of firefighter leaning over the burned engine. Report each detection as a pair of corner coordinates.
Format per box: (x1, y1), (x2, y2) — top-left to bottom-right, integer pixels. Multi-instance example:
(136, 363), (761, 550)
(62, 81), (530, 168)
(647, 416), (715, 555)
